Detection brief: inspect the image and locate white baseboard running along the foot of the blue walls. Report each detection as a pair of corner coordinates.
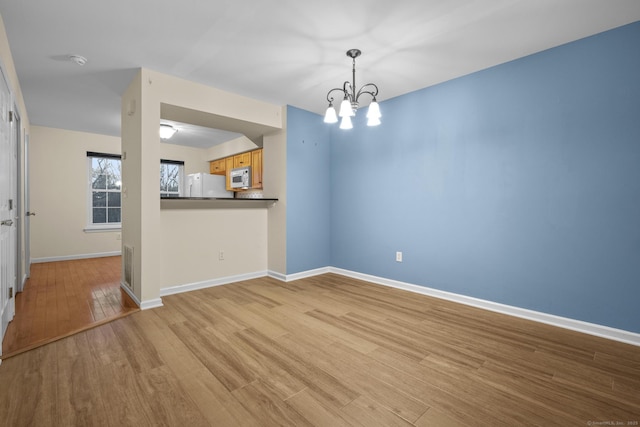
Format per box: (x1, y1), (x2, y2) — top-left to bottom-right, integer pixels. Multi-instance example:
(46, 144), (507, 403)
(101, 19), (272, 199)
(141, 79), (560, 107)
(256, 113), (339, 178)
(284, 267), (640, 346)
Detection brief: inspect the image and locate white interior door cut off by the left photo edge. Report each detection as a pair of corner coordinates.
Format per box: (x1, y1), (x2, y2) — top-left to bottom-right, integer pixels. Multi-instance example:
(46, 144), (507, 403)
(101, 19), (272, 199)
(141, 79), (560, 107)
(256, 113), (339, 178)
(0, 68), (17, 342)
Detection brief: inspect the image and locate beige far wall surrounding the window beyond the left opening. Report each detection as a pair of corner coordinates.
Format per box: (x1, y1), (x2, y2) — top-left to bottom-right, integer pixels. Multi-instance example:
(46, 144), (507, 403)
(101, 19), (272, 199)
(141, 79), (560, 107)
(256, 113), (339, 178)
(29, 126), (120, 262)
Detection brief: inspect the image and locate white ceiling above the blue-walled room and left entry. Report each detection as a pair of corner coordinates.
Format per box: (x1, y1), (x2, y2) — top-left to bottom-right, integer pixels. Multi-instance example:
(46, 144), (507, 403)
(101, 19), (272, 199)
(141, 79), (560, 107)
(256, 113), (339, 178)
(0, 0), (640, 144)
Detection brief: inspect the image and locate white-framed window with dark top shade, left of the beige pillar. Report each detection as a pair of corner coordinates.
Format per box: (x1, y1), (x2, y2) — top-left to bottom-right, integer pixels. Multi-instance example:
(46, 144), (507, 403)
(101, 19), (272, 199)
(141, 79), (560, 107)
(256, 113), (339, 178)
(87, 152), (122, 228)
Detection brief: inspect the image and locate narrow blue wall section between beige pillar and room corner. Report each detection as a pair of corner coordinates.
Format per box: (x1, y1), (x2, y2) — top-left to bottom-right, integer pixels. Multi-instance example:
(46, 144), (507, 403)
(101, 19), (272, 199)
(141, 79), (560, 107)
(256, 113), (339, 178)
(287, 106), (331, 274)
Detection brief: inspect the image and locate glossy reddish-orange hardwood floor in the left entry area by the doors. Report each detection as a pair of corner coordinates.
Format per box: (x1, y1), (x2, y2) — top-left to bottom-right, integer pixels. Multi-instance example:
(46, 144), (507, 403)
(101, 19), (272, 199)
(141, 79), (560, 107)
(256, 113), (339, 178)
(2, 256), (138, 359)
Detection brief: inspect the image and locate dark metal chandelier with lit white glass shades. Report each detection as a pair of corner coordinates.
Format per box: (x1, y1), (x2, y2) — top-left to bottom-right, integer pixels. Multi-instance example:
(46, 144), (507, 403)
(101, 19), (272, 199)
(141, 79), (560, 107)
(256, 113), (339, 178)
(324, 49), (382, 129)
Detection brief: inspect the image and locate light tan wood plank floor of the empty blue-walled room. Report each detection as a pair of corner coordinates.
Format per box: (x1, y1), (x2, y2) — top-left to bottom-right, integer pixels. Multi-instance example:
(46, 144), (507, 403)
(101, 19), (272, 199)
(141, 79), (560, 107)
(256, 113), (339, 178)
(0, 274), (640, 426)
